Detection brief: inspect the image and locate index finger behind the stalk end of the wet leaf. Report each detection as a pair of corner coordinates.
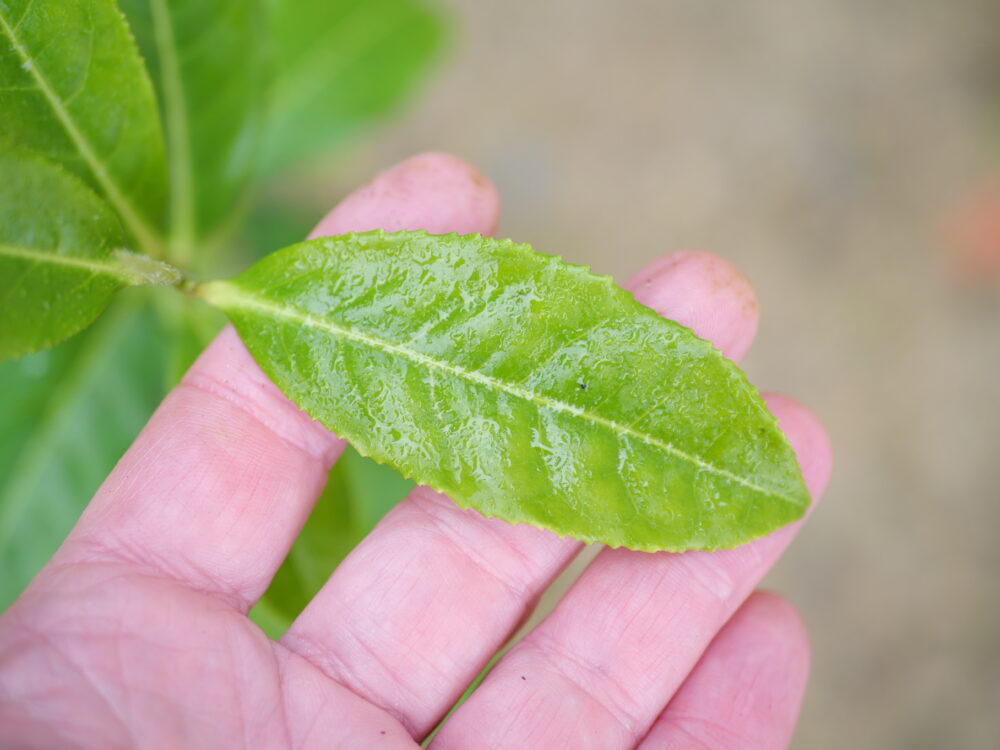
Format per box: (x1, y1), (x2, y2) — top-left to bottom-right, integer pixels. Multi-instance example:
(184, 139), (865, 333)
(46, 154), (499, 611)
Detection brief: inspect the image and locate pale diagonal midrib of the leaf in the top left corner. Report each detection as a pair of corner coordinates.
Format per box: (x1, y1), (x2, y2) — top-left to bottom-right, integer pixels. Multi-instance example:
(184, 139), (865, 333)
(0, 7), (159, 256)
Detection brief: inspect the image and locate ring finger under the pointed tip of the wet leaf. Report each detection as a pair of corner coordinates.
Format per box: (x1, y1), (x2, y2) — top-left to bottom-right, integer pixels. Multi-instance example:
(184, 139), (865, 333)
(435, 396), (830, 748)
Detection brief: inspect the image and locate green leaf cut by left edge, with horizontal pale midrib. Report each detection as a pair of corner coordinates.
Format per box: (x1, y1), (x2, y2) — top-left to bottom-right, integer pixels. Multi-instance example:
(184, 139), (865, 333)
(0, 142), (176, 360)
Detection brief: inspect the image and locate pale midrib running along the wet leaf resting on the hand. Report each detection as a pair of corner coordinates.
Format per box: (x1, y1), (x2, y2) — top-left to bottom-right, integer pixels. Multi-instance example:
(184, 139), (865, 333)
(213, 282), (802, 507)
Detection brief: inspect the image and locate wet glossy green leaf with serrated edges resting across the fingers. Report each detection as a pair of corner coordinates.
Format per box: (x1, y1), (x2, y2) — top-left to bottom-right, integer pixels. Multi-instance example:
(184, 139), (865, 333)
(200, 232), (809, 551)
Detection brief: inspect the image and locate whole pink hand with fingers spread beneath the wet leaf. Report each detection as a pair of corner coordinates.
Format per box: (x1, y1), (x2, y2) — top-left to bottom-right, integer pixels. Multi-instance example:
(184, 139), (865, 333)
(0, 153), (830, 750)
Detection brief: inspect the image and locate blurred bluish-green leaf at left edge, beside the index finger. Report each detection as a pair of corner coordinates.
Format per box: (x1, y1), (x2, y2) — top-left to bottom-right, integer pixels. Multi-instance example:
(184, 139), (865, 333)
(0, 293), (165, 611)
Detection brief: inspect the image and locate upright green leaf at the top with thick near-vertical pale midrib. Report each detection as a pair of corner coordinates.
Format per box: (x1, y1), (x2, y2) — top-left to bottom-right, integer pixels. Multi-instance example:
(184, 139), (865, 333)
(121, 0), (267, 262)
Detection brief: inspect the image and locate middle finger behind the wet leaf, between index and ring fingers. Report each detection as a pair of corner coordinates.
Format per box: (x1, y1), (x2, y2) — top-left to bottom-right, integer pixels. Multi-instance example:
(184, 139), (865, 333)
(283, 253), (757, 737)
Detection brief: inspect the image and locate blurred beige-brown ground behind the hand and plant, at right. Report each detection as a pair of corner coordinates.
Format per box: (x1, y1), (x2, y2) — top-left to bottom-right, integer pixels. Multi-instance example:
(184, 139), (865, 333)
(276, 0), (1000, 750)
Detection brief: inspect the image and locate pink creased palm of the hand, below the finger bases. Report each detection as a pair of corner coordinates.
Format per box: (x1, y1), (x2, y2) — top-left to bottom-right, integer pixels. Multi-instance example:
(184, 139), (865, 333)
(3, 561), (416, 748)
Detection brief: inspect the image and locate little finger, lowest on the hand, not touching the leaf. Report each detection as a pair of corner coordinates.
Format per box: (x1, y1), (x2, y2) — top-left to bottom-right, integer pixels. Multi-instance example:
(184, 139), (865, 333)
(639, 591), (809, 750)
